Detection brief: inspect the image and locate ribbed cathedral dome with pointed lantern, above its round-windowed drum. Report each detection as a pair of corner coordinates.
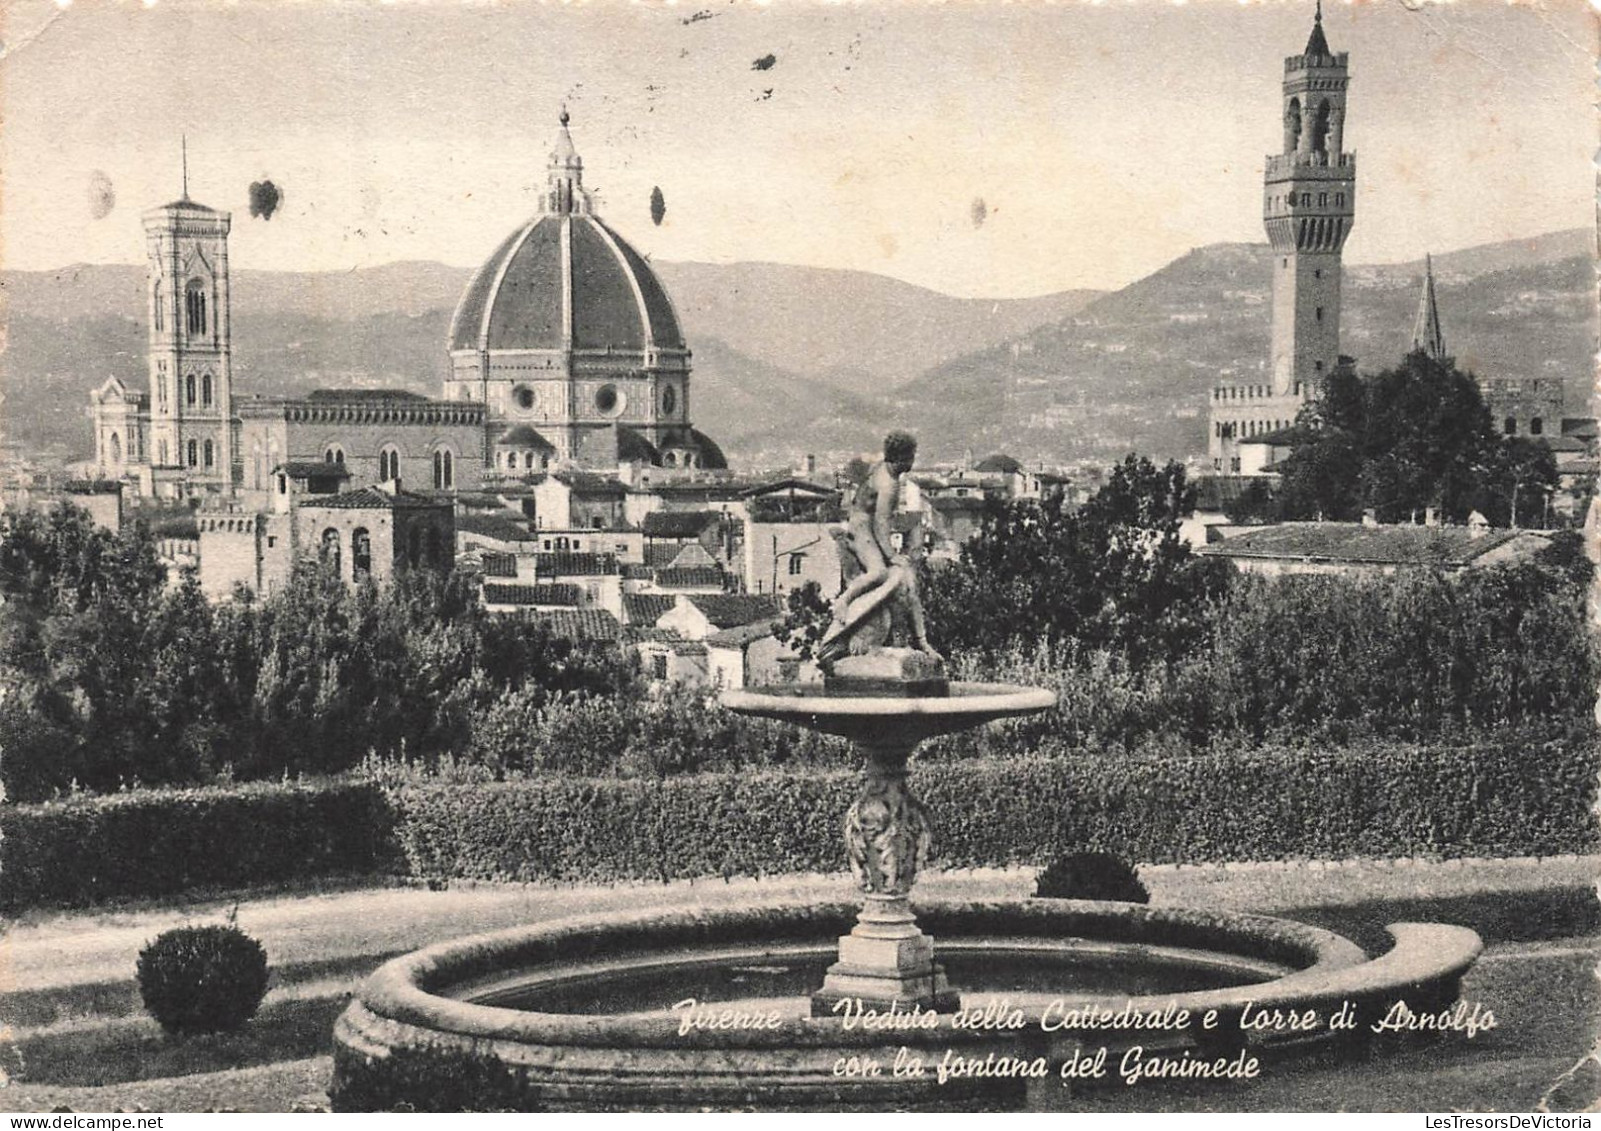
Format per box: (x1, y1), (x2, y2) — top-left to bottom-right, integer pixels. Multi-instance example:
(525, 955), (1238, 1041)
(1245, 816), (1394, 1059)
(450, 117), (684, 352)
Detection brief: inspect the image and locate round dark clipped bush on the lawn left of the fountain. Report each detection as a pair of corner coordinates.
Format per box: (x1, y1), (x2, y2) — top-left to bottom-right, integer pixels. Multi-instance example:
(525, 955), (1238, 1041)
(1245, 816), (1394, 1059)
(139, 924), (267, 1033)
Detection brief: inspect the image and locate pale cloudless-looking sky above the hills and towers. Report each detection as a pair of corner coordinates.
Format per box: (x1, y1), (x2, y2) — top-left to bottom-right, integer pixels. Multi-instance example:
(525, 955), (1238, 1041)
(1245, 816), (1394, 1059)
(0, 0), (1596, 296)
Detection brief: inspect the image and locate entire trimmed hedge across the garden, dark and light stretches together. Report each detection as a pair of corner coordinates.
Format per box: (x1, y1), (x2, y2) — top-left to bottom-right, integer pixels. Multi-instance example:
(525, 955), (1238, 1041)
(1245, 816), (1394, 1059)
(0, 734), (1601, 912)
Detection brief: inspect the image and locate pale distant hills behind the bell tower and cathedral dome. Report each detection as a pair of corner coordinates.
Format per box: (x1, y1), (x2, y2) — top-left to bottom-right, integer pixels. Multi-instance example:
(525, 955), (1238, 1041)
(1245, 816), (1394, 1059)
(0, 263), (1095, 461)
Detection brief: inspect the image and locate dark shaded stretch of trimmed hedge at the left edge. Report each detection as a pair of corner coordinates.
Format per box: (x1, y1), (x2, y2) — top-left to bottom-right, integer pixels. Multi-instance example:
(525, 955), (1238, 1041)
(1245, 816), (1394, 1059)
(0, 782), (394, 913)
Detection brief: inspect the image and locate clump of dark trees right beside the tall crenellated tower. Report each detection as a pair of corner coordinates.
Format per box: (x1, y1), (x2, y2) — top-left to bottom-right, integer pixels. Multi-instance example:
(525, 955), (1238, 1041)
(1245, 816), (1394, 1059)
(1249, 351), (1558, 525)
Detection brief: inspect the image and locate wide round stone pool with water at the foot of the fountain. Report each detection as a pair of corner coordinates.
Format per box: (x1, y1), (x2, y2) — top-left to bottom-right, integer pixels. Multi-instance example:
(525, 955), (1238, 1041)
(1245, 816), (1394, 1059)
(335, 900), (1476, 1110)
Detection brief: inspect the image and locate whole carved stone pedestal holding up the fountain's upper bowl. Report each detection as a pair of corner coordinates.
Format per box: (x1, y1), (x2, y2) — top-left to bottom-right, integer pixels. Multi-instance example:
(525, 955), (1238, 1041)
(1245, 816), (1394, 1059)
(812, 739), (959, 1017)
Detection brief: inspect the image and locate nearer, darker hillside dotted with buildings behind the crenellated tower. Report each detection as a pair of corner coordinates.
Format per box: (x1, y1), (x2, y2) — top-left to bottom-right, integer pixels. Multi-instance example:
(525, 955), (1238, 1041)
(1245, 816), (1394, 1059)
(890, 232), (1596, 460)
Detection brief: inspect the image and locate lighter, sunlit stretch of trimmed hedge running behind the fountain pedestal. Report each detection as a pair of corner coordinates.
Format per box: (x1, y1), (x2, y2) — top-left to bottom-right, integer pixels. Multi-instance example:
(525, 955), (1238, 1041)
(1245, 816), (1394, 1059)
(394, 737), (1598, 883)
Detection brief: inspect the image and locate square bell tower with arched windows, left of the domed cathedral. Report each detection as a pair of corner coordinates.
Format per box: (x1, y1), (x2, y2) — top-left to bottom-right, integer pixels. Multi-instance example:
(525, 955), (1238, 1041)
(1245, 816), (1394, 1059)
(144, 167), (235, 495)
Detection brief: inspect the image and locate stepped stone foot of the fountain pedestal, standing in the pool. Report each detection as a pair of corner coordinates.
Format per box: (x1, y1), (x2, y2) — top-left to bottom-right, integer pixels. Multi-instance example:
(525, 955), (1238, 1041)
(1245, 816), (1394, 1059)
(812, 896), (961, 1017)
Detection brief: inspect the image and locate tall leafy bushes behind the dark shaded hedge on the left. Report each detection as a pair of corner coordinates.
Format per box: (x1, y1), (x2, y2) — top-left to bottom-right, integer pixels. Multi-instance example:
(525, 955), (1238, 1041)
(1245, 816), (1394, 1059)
(0, 508), (631, 799)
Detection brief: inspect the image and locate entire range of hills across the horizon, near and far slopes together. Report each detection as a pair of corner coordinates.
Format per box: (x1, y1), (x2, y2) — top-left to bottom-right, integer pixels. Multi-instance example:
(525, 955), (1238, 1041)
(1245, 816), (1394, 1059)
(9, 232), (1596, 466)
